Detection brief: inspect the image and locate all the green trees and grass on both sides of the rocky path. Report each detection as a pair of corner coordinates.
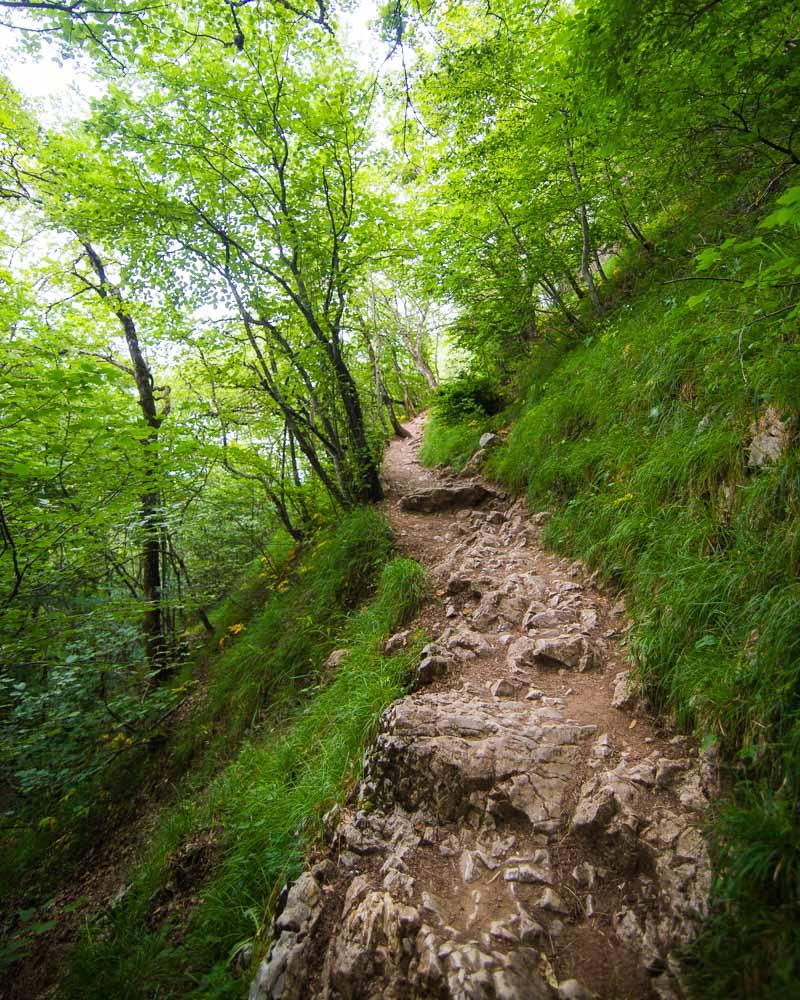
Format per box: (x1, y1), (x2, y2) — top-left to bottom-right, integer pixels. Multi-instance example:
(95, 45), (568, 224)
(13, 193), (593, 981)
(0, 0), (800, 997)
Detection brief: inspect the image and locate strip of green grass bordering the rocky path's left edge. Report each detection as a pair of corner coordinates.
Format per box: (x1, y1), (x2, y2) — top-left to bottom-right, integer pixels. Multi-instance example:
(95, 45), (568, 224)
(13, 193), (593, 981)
(20, 509), (425, 998)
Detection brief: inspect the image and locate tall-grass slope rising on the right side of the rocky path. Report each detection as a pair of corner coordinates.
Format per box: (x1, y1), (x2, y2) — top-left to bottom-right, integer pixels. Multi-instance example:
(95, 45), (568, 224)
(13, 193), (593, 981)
(423, 186), (800, 998)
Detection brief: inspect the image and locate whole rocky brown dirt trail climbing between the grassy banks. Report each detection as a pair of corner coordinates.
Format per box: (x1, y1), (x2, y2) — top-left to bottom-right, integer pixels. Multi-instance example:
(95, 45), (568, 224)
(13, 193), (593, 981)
(250, 418), (717, 1000)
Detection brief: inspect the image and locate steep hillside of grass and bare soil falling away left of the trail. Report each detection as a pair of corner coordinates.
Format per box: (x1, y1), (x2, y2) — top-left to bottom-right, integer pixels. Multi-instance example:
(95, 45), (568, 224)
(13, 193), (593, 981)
(0, 509), (426, 998)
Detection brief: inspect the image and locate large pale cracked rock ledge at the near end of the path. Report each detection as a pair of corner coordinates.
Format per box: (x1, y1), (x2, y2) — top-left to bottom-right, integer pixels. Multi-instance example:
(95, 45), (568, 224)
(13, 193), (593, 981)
(250, 664), (714, 1000)
